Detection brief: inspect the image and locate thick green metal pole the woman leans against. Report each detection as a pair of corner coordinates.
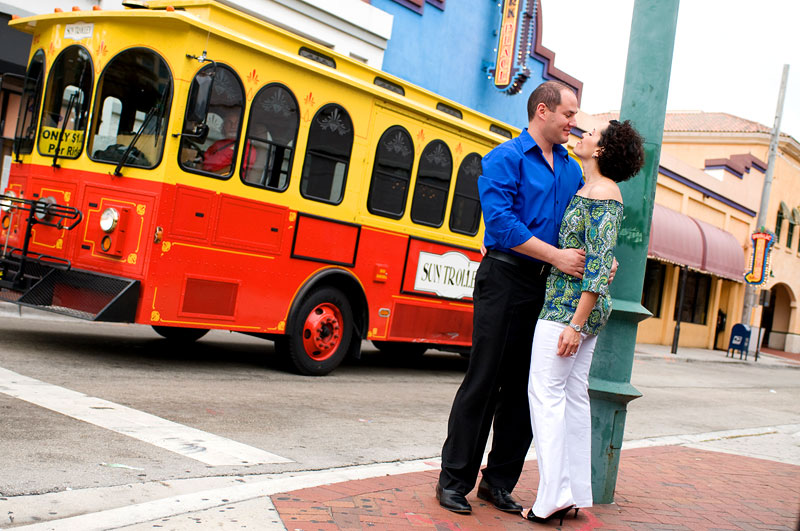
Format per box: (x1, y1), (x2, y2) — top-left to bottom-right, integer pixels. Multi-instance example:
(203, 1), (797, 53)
(589, 0), (679, 503)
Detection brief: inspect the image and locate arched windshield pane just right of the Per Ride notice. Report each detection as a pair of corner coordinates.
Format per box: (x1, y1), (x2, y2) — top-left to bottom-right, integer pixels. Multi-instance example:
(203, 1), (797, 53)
(88, 48), (172, 168)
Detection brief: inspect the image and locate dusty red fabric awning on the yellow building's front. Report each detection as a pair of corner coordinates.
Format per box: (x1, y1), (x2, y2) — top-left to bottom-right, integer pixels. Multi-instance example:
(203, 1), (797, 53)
(647, 205), (745, 282)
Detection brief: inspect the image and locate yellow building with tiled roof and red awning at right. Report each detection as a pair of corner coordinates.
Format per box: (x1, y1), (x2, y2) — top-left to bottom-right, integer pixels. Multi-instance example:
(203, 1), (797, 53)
(582, 112), (800, 353)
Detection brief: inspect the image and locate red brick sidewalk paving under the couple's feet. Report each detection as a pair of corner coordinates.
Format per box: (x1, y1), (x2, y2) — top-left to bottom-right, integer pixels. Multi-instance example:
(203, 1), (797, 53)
(272, 446), (800, 531)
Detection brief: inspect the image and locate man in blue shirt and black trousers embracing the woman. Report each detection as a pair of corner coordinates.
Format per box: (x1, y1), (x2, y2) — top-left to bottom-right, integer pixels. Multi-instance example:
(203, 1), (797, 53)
(436, 81), (585, 513)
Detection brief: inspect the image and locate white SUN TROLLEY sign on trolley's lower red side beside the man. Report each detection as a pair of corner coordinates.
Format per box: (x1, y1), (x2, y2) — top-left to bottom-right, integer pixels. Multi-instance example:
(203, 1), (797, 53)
(414, 251), (480, 299)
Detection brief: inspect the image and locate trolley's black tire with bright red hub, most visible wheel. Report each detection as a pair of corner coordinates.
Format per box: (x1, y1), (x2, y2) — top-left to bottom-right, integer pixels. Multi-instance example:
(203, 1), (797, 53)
(275, 287), (353, 376)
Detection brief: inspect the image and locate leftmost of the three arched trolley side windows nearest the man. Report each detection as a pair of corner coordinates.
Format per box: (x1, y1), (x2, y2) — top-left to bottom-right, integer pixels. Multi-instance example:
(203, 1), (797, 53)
(367, 125), (414, 219)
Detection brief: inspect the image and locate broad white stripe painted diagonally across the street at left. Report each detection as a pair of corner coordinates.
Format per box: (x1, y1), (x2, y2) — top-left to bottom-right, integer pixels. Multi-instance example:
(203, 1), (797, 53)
(0, 368), (292, 466)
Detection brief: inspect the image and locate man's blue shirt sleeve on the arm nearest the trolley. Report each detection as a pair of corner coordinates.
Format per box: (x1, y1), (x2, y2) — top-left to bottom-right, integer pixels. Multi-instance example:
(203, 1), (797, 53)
(478, 145), (533, 249)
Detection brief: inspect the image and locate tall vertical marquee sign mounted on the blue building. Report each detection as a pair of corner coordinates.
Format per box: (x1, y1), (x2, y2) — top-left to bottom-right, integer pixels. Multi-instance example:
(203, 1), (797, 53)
(490, 0), (537, 94)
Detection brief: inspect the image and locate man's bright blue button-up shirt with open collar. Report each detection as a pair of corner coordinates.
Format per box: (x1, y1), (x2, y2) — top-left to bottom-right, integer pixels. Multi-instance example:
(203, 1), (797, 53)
(478, 129), (583, 258)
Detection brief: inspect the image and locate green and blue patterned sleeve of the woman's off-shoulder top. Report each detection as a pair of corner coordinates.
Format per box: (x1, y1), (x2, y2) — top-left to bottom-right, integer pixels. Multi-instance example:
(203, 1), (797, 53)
(581, 201), (622, 295)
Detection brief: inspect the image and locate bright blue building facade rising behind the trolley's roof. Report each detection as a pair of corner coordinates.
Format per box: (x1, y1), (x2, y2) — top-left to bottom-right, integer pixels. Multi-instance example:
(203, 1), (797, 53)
(371, 0), (583, 128)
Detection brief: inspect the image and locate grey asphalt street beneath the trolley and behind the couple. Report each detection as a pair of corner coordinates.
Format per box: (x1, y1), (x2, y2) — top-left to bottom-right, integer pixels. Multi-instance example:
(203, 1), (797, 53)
(0, 305), (800, 529)
